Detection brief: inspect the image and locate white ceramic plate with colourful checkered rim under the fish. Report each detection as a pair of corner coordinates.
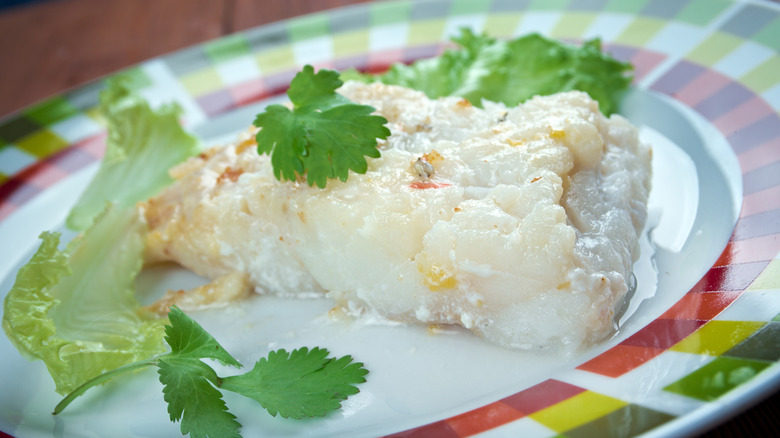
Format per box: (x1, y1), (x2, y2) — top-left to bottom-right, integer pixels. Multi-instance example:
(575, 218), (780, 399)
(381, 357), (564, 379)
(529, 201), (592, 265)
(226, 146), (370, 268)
(0, 0), (780, 437)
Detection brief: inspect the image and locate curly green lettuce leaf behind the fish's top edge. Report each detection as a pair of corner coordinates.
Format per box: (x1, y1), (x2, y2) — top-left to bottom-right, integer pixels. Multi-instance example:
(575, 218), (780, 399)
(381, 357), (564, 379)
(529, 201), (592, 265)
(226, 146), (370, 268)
(342, 29), (632, 115)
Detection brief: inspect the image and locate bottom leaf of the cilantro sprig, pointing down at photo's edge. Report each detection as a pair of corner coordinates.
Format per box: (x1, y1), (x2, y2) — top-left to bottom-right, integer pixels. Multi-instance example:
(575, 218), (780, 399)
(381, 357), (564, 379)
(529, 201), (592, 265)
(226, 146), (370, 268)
(158, 356), (241, 438)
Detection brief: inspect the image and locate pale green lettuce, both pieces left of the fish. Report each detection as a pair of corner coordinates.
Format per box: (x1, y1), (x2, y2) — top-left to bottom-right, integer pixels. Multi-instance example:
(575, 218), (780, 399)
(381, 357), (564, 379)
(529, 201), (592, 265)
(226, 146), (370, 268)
(2, 81), (198, 394)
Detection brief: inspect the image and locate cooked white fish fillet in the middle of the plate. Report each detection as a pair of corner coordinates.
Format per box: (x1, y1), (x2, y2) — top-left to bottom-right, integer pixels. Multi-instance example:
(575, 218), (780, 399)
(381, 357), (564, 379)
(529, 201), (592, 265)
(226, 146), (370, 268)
(142, 82), (651, 350)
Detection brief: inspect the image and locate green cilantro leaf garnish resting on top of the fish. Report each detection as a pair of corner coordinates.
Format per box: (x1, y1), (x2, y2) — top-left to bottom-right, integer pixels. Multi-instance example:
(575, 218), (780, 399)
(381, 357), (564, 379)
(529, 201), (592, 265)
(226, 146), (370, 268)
(254, 65), (390, 188)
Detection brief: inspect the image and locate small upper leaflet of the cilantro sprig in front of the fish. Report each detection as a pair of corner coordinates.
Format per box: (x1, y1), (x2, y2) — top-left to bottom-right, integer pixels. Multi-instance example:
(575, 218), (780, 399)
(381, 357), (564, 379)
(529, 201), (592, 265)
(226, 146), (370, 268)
(163, 306), (242, 368)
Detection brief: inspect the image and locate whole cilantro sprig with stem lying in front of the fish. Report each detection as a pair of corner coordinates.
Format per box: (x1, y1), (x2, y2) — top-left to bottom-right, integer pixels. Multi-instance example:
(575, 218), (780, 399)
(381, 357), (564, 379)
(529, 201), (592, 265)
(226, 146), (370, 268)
(53, 306), (368, 438)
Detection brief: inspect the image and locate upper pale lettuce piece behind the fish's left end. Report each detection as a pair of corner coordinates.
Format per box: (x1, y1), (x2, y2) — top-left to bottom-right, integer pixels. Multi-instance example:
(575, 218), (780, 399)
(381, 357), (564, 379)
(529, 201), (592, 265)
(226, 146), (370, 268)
(66, 79), (200, 231)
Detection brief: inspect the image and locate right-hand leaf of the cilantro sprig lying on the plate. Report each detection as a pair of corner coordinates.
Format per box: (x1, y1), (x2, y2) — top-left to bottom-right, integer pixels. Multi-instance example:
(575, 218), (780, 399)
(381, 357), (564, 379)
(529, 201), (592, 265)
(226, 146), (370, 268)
(222, 348), (368, 419)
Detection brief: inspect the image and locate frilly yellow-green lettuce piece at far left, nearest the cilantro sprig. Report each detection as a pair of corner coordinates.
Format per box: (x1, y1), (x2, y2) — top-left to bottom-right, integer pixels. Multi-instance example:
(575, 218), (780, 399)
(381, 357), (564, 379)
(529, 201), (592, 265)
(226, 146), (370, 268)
(3, 205), (167, 394)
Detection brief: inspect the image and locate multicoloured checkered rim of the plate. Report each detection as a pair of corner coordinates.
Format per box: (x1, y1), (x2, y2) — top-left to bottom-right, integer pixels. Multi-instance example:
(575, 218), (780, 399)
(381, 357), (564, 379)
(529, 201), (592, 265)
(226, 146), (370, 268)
(0, 0), (780, 437)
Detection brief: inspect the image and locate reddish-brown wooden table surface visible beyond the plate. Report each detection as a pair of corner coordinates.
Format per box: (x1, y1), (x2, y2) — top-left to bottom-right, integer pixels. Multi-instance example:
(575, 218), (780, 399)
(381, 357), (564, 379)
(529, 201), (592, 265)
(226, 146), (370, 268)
(0, 0), (780, 437)
